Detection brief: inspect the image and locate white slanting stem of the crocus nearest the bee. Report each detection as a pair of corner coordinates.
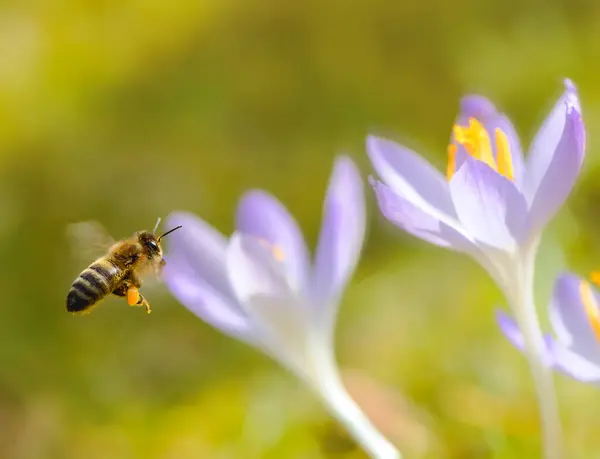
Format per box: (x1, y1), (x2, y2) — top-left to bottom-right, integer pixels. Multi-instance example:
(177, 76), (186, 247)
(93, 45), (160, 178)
(313, 361), (402, 459)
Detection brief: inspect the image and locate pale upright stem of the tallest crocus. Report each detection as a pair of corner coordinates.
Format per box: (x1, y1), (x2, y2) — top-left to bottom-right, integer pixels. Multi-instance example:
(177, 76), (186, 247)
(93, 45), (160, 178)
(511, 244), (562, 459)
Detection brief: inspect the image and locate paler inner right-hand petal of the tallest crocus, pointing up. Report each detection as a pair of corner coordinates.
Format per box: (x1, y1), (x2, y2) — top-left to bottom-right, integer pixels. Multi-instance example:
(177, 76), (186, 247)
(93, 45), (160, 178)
(524, 79), (581, 203)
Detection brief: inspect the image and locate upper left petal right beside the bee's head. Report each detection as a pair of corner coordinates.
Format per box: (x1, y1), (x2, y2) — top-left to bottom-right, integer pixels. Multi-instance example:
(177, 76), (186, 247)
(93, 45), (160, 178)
(166, 212), (233, 297)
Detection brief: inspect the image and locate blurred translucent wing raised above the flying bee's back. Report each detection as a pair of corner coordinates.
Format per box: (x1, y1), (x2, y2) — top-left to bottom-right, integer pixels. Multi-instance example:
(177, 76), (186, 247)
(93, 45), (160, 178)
(67, 220), (115, 264)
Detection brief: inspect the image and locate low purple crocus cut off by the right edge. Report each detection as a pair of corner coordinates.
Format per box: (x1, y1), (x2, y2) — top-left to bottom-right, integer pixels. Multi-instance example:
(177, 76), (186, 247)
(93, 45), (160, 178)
(497, 274), (600, 384)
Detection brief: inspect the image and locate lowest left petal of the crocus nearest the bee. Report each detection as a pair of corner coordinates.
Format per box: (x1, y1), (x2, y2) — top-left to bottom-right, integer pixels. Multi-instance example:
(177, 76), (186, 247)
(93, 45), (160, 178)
(163, 257), (254, 343)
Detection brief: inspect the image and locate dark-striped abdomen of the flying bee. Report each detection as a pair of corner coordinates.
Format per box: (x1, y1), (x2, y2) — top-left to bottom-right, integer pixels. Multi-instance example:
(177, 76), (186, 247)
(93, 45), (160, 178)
(67, 258), (121, 312)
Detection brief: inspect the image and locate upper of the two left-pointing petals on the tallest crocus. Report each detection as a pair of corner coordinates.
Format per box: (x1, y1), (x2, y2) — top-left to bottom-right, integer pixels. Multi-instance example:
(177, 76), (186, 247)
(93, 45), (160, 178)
(367, 136), (456, 216)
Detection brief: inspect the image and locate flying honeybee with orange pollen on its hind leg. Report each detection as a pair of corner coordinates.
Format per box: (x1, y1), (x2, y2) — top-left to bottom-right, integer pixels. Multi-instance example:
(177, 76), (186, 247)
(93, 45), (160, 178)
(67, 218), (181, 314)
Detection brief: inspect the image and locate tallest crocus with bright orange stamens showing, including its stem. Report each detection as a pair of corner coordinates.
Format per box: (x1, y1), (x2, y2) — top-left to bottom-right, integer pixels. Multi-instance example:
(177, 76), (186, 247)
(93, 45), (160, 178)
(367, 80), (585, 458)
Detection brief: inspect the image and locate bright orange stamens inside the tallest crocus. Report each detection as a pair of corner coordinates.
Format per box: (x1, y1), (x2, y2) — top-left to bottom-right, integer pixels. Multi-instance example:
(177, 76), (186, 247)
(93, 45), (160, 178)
(446, 118), (514, 180)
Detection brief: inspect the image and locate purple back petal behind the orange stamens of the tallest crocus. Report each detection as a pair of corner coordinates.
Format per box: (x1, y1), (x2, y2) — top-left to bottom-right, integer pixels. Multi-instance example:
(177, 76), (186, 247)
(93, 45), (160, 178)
(457, 95), (525, 187)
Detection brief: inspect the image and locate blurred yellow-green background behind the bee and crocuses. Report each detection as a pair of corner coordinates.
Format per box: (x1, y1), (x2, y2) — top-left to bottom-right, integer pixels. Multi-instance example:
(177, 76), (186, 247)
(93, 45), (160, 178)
(0, 0), (600, 459)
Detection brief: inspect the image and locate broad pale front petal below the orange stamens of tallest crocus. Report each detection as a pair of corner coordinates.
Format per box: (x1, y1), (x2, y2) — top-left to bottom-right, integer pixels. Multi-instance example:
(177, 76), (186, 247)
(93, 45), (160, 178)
(450, 158), (527, 250)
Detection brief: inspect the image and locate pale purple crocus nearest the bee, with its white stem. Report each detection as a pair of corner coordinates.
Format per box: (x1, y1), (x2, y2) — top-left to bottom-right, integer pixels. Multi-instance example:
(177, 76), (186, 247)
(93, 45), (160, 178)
(164, 157), (400, 459)
